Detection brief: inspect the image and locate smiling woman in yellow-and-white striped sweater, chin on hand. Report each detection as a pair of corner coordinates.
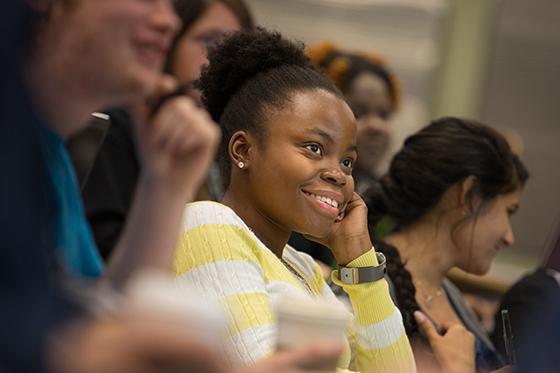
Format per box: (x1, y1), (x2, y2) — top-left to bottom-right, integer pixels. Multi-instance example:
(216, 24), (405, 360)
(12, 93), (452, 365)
(171, 30), (414, 372)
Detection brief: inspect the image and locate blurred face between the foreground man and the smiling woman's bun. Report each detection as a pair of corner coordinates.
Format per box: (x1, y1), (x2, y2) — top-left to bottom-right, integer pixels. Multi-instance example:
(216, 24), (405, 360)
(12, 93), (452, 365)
(171, 2), (241, 83)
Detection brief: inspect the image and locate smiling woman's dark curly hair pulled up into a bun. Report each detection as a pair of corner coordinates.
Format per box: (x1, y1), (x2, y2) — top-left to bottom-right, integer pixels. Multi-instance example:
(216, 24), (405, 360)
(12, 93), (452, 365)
(196, 28), (343, 186)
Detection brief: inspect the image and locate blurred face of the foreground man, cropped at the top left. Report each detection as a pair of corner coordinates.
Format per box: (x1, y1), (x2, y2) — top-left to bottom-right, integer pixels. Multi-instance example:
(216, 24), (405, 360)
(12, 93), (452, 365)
(44, 0), (179, 105)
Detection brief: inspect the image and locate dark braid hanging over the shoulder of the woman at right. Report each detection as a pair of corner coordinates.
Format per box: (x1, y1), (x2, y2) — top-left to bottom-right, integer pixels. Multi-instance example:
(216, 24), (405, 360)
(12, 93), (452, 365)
(374, 241), (420, 338)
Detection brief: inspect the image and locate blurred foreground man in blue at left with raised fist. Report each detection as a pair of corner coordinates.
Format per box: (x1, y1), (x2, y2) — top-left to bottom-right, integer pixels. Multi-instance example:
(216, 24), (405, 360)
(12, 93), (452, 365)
(0, 0), (339, 372)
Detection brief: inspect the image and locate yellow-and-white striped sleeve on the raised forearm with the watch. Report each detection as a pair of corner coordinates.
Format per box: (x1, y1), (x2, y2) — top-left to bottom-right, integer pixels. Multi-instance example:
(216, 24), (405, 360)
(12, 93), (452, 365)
(332, 249), (416, 372)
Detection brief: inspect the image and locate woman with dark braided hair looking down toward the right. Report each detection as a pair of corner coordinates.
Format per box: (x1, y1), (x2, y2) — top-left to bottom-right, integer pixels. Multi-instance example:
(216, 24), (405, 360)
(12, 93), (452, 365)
(364, 117), (528, 371)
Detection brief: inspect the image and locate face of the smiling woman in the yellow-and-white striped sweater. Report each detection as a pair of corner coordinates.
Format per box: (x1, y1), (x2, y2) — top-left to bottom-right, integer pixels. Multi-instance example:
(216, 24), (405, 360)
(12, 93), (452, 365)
(248, 90), (356, 237)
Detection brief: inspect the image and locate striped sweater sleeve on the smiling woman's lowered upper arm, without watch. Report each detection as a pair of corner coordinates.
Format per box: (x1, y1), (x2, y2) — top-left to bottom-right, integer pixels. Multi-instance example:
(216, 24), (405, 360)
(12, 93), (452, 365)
(174, 218), (276, 363)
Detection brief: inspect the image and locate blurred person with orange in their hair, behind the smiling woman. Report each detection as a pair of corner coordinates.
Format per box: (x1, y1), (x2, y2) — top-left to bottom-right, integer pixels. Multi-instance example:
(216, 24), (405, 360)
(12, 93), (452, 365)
(290, 42), (400, 268)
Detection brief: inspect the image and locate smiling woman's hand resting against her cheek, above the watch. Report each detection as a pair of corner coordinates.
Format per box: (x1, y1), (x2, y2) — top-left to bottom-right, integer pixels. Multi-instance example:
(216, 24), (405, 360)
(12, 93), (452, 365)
(306, 193), (372, 265)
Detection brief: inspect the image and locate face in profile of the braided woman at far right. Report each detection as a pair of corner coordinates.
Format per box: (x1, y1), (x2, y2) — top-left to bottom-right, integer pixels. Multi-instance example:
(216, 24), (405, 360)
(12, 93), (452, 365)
(455, 189), (522, 275)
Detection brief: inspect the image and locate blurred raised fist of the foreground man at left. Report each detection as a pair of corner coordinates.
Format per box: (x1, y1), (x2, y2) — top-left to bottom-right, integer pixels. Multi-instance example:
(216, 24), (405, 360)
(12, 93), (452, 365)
(135, 77), (220, 199)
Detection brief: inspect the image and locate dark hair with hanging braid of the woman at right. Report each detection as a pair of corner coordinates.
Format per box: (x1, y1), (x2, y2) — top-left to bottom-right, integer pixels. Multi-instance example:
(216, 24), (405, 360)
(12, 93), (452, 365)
(364, 117), (529, 336)
